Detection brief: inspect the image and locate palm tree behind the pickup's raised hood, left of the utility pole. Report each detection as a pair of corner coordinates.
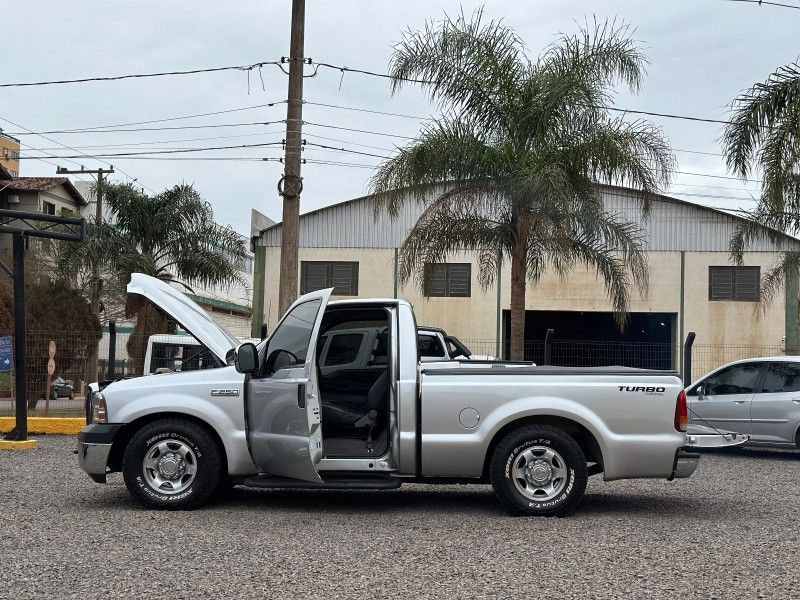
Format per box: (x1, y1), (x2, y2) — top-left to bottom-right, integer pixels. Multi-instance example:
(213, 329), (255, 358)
(59, 184), (245, 372)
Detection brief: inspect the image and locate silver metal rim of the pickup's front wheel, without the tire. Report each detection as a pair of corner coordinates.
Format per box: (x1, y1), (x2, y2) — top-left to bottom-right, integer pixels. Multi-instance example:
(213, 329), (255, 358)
(142, 439), (197, 495)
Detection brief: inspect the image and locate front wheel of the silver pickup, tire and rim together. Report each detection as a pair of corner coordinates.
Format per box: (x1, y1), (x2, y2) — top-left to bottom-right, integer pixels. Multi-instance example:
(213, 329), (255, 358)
(122, 419), (223, 510)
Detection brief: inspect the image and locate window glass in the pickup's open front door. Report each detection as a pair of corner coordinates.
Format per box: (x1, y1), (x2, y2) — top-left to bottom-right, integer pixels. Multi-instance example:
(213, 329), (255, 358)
(262, 300), (322, 376)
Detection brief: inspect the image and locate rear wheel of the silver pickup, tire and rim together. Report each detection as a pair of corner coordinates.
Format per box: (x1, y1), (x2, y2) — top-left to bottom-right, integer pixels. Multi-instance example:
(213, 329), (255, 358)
(490, 425), (589, 517)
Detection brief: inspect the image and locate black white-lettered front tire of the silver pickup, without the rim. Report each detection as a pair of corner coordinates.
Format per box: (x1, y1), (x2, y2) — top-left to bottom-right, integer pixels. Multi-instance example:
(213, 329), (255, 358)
(122, 419), (220, 510)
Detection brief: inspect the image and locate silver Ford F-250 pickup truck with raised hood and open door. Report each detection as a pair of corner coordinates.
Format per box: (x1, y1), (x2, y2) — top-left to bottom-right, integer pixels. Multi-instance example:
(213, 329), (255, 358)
(78, 274), (743, 516)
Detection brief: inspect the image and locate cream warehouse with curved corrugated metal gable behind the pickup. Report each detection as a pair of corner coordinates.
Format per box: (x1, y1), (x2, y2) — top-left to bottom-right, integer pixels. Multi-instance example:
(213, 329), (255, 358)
(253, 187), (800, 370)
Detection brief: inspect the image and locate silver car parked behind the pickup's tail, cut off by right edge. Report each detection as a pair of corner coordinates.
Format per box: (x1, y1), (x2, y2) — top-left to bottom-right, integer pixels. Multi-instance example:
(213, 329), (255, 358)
(686, 356), (800, 448)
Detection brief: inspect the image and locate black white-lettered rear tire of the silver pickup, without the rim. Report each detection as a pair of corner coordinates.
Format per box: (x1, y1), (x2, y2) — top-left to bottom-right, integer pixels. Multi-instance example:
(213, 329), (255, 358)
(490, 425), (589, 517)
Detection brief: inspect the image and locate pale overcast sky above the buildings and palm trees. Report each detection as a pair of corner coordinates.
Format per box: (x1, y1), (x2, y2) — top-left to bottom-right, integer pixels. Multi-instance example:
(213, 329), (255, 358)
(0, 0), (800, 233)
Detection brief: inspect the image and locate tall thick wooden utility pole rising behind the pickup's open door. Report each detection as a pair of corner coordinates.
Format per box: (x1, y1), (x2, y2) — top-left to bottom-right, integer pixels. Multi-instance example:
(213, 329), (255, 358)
(278, 0), (306, 314)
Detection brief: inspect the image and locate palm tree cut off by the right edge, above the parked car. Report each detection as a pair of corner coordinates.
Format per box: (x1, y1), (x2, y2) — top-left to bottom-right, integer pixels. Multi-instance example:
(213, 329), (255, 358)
(722, 63), (800, 307)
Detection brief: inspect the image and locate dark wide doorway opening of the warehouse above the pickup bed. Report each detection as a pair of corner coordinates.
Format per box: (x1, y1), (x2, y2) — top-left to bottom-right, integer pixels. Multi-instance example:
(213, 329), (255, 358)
(503, 310), (677, 369)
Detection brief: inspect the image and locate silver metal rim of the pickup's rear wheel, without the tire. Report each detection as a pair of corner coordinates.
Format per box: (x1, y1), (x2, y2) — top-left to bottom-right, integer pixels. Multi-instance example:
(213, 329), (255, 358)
(511, 446), (568, 502)
